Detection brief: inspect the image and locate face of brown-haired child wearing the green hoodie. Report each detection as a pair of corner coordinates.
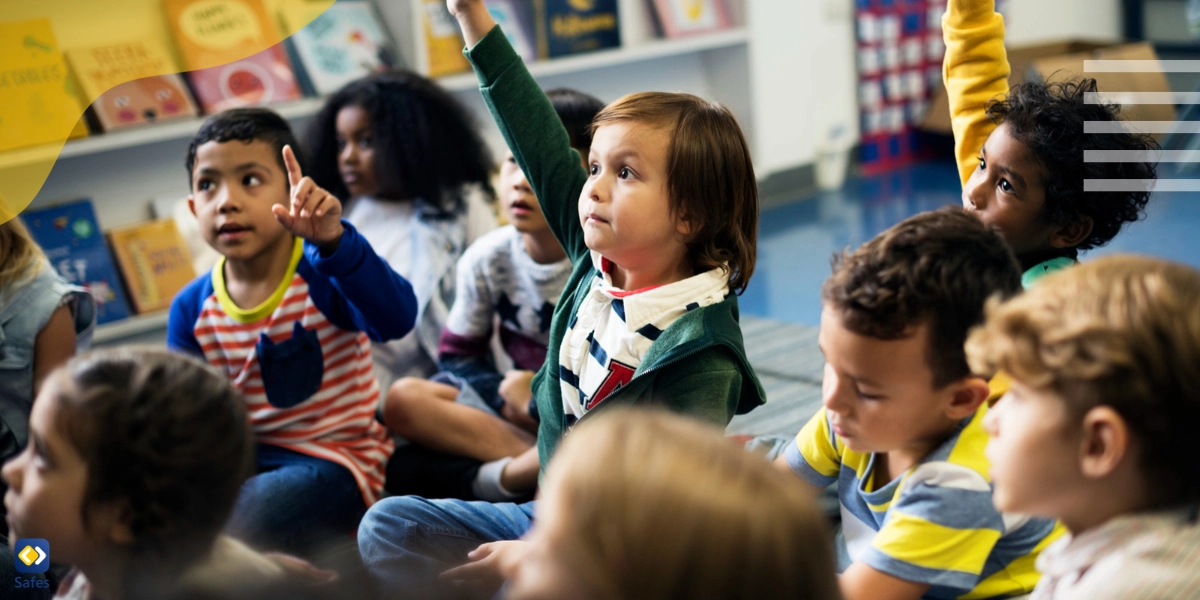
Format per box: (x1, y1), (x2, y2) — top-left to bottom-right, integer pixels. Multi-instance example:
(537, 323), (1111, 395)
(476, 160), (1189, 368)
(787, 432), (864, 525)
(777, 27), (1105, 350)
(580, 121), (688, 270)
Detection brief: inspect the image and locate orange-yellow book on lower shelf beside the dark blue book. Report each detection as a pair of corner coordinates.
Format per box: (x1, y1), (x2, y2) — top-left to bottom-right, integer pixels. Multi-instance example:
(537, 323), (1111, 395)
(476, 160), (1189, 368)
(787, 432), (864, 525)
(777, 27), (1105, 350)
(108, 218), (196, 314)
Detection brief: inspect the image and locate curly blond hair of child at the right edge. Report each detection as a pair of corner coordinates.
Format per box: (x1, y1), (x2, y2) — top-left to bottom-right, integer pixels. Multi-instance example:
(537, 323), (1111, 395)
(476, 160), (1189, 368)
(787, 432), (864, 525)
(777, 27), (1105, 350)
(966, 256), (1200, 506)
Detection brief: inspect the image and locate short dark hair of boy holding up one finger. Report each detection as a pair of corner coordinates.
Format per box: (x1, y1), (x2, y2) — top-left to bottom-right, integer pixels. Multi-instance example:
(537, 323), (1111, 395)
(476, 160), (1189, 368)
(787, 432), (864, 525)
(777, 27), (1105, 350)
(185, 108), (306, 188)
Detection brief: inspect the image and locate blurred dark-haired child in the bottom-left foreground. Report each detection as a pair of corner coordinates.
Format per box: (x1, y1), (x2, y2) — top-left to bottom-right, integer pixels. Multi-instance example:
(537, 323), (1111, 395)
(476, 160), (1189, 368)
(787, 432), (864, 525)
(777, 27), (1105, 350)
(4, 350), (255, 600)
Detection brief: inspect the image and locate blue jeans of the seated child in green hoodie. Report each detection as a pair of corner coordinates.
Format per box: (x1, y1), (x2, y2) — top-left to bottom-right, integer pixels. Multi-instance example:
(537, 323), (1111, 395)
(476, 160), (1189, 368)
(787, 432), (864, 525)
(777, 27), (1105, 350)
(359, 496), (535, 598)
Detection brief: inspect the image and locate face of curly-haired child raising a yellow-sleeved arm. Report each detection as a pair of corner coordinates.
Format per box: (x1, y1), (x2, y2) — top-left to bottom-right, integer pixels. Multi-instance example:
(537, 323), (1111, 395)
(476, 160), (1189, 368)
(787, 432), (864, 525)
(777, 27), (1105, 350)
(962, 124), (1057, 258)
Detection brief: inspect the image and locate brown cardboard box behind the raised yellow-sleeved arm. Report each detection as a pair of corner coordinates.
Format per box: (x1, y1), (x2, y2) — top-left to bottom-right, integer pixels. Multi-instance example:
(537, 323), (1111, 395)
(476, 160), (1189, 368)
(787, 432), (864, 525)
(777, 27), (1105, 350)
(922, 40), (1175, 133)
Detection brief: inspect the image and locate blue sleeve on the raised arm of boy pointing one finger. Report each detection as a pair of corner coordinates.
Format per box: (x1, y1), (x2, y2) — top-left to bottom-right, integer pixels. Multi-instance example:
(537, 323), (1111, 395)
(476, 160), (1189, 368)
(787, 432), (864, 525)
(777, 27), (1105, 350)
(296, 220), (416, 342)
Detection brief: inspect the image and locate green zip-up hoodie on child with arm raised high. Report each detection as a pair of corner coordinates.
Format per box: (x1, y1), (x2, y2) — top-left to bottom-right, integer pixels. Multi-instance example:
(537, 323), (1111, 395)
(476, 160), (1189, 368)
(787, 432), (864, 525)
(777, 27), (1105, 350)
(466, 26), (766, 470)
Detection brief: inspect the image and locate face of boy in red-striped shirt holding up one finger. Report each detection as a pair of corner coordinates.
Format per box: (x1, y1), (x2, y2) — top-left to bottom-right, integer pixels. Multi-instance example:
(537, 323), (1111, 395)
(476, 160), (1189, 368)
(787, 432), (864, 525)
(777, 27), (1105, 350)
(187, 139), (292, 265)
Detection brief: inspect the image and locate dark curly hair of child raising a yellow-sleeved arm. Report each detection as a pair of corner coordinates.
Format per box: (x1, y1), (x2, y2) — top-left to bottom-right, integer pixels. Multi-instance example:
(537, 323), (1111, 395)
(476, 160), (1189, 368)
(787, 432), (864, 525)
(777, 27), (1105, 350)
(988, 79), (1158, 250)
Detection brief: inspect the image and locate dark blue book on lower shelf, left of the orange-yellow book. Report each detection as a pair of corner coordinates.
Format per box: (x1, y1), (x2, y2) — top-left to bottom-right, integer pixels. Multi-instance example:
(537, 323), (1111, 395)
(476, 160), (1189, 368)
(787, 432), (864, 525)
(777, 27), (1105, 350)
(20, 200), (130, 325)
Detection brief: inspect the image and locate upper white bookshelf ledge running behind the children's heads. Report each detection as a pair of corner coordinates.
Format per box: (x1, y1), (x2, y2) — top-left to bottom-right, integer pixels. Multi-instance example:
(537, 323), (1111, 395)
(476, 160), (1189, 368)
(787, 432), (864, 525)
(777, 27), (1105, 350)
(0, 28), (748, 167)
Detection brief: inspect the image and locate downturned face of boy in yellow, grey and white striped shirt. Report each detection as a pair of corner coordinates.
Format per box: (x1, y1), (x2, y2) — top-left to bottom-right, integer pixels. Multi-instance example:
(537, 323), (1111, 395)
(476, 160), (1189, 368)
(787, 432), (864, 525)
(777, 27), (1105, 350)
(817, 306), (958, 456)
